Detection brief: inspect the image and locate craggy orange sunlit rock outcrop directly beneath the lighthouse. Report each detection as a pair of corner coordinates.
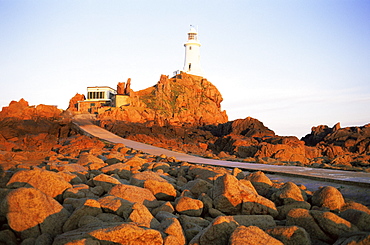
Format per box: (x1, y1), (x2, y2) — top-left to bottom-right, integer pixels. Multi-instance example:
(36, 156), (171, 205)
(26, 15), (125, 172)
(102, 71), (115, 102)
(99, 73), (228, 126)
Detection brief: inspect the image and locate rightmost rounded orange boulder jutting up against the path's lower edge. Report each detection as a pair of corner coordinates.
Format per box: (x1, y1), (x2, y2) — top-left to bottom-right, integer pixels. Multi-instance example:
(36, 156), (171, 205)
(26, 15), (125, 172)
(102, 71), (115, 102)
(312, 186), (345, 210)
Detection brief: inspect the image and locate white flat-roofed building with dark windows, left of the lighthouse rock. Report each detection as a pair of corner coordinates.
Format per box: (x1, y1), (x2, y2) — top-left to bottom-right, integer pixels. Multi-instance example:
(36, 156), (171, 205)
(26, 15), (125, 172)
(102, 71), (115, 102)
(78, 86), (117, 114)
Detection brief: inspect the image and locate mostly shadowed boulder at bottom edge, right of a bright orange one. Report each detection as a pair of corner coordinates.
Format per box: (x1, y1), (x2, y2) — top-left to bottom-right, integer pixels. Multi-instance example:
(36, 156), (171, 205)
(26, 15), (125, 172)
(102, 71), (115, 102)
(265, 226), (311, 245)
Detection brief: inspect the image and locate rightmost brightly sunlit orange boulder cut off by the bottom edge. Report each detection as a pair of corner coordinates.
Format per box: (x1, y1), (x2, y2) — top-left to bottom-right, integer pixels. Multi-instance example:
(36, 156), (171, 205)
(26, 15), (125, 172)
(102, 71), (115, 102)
(229, 226), (284, 245)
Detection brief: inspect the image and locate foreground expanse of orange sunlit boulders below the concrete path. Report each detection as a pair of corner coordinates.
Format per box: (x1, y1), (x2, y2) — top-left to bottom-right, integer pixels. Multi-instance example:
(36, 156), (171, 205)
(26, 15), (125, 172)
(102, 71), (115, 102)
(0, 135), (370, 244)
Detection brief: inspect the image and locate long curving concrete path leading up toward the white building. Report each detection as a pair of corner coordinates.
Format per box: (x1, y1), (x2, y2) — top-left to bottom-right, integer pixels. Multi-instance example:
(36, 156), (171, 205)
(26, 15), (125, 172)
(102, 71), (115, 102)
(74, 115), (370, 187)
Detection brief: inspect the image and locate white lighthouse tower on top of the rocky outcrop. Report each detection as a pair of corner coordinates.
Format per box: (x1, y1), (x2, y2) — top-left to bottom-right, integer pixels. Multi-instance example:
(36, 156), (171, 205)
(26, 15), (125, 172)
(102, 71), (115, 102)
(183, 26), (203, 76)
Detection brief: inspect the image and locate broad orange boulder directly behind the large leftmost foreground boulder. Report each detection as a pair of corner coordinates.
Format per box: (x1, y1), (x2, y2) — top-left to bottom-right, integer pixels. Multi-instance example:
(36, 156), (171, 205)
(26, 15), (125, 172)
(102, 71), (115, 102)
(7, 169), (72, 199)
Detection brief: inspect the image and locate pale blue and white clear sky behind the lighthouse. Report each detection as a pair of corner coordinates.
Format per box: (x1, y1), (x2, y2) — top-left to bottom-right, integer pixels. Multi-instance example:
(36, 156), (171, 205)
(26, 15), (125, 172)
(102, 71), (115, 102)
(0, 0), (370, 137)
